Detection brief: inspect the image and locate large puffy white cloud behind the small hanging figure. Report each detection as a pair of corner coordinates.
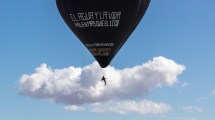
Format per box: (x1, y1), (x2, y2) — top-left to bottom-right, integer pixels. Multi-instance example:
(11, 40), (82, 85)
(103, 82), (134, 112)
(19, 56), (185, 112)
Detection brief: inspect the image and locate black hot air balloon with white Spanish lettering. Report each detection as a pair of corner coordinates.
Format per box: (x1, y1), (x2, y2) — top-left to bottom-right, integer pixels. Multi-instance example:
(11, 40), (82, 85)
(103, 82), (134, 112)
(56, 0), (150, 68)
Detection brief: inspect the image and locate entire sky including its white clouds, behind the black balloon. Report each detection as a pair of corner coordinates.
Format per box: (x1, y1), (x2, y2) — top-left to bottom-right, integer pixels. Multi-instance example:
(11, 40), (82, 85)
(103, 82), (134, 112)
(0, 0), (215, 120)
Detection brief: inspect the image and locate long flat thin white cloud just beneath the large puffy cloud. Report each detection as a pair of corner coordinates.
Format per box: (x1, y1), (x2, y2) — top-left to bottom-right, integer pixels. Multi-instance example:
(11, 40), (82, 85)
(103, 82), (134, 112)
(92, 100), (172, 115)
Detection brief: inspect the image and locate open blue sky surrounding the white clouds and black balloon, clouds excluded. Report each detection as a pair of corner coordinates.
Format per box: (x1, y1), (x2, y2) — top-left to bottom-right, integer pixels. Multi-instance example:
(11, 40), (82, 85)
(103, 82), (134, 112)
(0, 0), (215, 120)
